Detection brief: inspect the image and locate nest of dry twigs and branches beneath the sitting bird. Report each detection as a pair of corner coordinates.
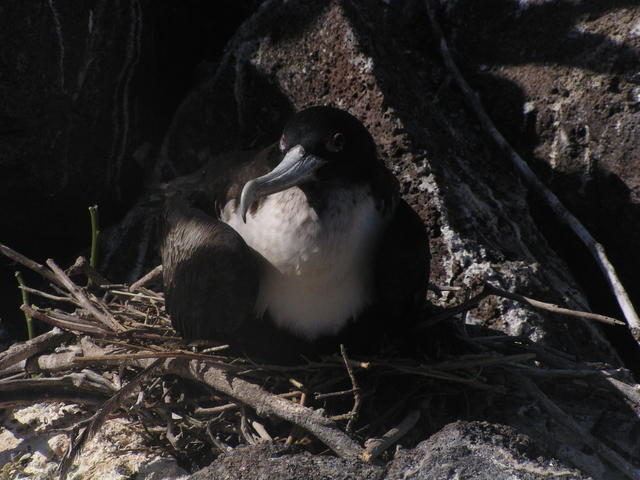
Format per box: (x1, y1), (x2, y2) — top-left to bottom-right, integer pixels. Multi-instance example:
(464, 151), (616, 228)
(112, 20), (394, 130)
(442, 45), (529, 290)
(0, 245), (640, 477)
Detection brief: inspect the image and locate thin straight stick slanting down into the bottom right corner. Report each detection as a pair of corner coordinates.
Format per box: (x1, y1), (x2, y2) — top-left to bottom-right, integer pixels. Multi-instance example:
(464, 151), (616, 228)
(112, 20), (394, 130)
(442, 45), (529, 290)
(520, 376), (640, 480)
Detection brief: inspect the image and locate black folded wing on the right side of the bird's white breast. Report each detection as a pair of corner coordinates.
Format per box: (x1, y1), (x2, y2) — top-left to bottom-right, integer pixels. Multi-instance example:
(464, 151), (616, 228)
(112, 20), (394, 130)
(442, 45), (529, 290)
(376, 200), (431, 326)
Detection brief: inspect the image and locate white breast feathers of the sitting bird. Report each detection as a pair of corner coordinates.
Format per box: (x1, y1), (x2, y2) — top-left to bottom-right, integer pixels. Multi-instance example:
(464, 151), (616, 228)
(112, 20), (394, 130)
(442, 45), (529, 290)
(222, 187), (384, 340)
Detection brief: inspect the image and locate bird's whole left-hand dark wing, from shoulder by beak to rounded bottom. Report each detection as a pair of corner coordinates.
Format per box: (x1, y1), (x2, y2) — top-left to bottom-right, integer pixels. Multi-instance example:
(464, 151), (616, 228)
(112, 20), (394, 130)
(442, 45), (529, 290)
(160, 149), (272, 340)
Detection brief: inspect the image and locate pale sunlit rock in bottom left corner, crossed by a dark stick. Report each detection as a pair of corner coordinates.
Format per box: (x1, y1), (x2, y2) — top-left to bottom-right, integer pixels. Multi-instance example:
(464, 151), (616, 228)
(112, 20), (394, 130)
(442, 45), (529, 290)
(0, 403), (186, 480)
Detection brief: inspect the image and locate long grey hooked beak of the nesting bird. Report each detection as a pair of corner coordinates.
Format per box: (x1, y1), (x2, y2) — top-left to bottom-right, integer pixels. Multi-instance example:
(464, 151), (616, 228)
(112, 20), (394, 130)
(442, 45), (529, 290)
(240, 145), (326, 222)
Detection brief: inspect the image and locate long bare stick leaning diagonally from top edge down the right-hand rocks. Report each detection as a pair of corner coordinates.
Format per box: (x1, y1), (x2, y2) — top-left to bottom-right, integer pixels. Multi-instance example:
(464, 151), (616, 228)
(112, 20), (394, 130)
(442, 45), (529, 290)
(426, 0), (640, 342)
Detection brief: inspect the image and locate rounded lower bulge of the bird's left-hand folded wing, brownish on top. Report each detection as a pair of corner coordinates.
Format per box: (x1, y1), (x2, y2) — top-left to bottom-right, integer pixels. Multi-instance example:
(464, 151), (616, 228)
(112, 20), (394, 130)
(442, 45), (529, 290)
(161, 200), (260, 340)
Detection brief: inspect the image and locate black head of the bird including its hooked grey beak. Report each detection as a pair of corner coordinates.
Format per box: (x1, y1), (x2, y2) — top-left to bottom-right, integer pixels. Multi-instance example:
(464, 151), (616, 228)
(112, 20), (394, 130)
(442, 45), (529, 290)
(240, 106), (377, 221)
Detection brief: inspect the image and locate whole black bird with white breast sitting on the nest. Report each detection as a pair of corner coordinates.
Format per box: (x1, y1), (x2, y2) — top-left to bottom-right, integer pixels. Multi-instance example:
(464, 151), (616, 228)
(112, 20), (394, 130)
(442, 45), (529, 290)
(160, 106), (430, 358)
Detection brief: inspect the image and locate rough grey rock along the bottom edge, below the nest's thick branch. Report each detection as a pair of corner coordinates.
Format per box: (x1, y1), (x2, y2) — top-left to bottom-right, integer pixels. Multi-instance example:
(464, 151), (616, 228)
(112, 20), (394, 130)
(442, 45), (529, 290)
(189, 422), (587, 480)
